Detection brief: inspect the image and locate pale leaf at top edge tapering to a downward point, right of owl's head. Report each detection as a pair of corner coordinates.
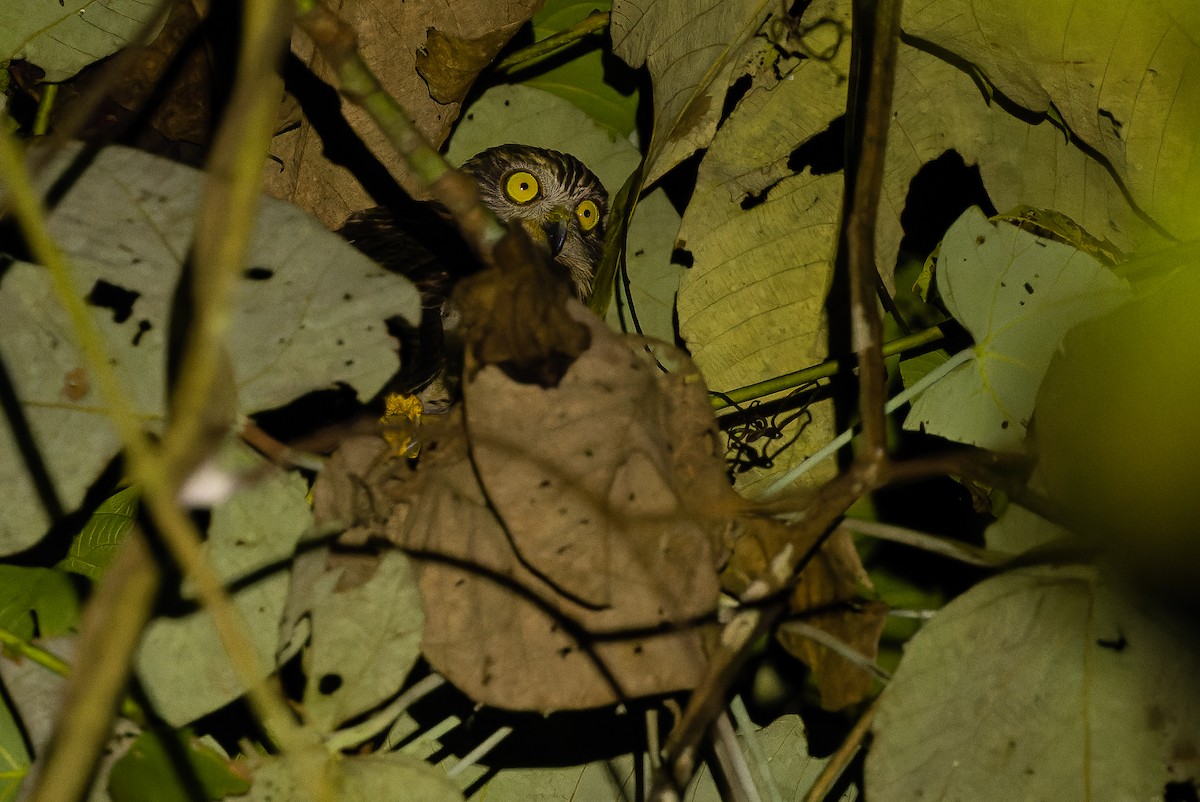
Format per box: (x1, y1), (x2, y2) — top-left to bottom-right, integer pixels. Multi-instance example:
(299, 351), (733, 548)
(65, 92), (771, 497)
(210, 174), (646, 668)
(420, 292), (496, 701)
(610, 0), (773, 184)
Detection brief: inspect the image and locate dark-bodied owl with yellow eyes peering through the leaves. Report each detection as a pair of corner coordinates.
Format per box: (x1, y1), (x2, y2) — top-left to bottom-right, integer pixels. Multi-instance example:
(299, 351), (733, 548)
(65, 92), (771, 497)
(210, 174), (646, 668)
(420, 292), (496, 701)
(338, 145), (608, 398)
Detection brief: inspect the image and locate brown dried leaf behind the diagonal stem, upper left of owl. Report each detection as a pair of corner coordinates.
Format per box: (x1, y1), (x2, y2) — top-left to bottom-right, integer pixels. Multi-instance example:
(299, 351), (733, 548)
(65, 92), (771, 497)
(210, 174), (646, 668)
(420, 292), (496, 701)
(274, 0), (542, 228)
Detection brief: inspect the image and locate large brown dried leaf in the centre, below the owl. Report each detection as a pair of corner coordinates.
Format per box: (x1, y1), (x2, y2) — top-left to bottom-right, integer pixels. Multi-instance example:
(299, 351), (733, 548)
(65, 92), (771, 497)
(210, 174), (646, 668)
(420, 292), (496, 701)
(390, 304), (737, 710)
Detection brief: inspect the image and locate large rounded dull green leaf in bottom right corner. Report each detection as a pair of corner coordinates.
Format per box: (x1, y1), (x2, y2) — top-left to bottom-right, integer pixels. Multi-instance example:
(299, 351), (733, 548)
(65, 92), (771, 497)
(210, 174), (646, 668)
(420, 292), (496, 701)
(865, 567), (1200, 802)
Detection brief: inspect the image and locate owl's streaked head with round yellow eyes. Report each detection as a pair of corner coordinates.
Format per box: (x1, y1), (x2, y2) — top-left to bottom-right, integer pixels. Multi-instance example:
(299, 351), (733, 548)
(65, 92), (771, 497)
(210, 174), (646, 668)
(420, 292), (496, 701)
(462, 145), (608, 298)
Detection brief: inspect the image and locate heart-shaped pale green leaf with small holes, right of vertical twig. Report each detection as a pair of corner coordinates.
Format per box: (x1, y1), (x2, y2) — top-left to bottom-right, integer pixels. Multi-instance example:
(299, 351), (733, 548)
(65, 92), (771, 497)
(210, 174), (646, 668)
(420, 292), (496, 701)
(904, 207), (1129, 450)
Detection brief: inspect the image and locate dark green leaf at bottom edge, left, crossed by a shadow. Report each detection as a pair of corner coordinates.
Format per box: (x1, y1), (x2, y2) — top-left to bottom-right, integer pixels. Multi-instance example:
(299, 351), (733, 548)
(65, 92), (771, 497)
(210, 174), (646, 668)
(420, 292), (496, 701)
(108, 729), (250, 802)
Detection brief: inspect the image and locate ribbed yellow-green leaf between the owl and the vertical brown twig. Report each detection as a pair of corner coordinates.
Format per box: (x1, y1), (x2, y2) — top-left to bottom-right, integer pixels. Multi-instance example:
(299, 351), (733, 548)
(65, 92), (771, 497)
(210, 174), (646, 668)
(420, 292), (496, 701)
(678, 48), (848, 495)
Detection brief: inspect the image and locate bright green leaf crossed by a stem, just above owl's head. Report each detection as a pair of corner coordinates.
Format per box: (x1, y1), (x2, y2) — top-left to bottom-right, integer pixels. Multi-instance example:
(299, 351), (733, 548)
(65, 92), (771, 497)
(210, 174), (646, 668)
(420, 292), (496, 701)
(523, 0), (637, 138)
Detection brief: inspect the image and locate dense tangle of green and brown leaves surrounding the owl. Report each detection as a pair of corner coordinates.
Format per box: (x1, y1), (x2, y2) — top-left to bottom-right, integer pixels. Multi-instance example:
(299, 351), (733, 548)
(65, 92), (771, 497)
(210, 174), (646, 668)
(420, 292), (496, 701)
(0, 0), (1200, 802)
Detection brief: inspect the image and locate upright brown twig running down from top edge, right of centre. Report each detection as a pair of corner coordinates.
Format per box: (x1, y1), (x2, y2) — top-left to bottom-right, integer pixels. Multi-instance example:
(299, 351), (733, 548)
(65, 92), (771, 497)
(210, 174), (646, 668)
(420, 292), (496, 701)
(841, 0), (900, 466)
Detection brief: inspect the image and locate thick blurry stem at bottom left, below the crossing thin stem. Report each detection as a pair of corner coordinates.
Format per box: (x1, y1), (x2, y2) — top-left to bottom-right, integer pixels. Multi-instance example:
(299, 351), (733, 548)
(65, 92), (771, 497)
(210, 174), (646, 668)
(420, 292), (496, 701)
(30, 526), (162, 802)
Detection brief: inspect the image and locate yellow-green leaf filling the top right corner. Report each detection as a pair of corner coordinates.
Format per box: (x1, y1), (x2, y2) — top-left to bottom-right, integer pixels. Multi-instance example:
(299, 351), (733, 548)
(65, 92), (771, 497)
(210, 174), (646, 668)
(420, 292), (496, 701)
(904, 0), (1200, 238)
